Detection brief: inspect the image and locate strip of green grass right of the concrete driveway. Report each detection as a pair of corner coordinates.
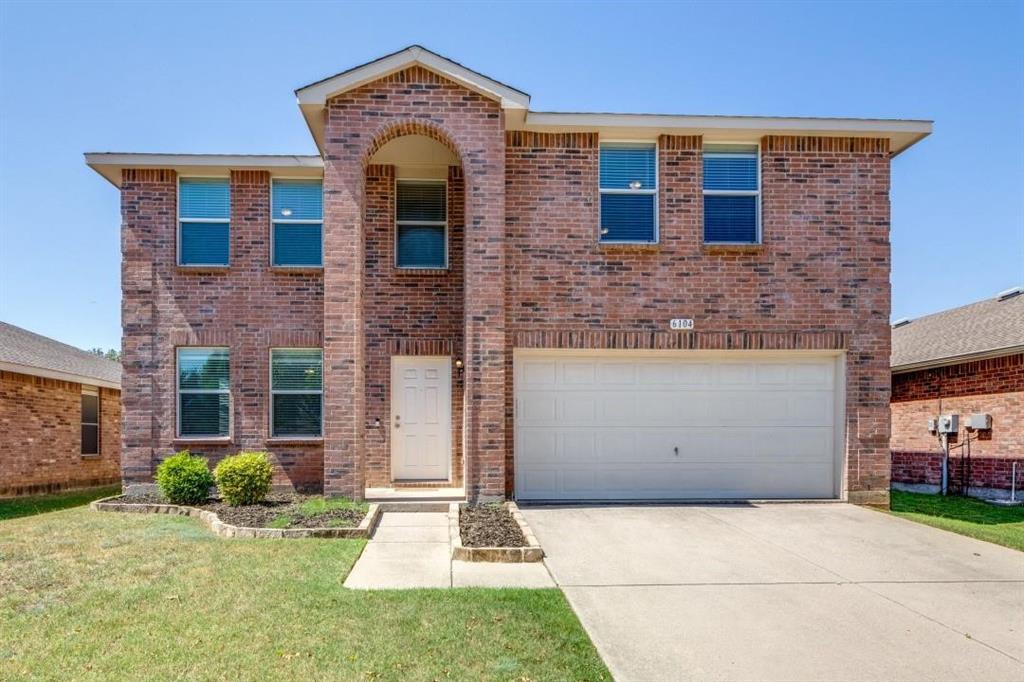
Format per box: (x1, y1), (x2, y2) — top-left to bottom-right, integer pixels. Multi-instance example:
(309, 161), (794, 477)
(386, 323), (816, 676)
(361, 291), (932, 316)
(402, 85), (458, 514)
(890, 491), (1024, 552)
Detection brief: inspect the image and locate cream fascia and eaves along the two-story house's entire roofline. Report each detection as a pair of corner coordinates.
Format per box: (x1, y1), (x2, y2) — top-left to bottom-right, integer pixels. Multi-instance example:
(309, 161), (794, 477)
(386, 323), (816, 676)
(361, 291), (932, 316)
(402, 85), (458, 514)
(85, 45), (932, 186)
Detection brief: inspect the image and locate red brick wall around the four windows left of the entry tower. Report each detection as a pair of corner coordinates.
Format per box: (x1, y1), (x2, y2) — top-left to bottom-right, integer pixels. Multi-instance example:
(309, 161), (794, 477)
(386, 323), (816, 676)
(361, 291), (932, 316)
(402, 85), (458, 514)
(122, 170), (324, 488)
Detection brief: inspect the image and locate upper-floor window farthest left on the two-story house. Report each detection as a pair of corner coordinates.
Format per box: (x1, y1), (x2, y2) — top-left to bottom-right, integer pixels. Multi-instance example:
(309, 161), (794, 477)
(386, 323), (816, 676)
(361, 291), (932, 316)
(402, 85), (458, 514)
(178, 177), (231, 265)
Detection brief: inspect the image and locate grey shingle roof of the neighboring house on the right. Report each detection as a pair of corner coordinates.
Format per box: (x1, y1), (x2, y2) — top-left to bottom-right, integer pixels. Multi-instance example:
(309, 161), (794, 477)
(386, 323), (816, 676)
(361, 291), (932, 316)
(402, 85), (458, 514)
(892, 288), (1024, 372)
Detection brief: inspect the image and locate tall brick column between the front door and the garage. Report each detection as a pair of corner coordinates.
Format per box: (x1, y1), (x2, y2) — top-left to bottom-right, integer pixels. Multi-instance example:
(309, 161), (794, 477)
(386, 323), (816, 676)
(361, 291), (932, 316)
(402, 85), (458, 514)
(462, 129), (506, 500)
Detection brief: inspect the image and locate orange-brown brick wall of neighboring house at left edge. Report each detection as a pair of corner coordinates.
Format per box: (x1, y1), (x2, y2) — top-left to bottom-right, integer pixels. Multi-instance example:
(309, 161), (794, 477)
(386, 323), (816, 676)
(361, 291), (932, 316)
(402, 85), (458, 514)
(0, 372), (121, 497)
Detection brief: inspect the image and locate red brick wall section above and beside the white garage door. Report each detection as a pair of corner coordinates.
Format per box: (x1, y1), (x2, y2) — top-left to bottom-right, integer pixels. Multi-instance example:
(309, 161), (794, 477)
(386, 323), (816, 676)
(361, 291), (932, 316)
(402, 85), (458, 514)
(506, 132), (890, 503)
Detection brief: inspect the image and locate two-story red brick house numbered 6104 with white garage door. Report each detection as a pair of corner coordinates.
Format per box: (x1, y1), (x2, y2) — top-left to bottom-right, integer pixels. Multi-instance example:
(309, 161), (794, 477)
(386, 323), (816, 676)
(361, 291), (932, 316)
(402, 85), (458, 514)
(86, 42), (931, 504)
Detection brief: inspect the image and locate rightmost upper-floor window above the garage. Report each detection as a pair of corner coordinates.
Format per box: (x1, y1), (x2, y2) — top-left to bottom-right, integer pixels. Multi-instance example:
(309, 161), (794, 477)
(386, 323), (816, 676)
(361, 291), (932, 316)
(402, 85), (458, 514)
(703, 144), (761, 244)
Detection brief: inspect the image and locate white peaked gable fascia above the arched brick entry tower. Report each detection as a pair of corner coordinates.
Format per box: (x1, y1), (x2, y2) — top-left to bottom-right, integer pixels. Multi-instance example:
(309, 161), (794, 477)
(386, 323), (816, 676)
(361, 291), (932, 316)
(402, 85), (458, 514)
(295, 46), (529, 110)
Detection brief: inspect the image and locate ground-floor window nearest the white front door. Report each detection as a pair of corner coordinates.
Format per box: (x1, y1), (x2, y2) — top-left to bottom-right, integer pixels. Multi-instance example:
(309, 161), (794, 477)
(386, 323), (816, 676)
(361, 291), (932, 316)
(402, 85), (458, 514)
(270, 348), (324, 437)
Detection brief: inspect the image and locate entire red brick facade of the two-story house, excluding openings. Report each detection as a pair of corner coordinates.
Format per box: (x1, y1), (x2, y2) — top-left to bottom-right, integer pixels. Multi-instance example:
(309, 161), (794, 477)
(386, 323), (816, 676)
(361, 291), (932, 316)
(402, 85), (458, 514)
(116, 68), (890, 502)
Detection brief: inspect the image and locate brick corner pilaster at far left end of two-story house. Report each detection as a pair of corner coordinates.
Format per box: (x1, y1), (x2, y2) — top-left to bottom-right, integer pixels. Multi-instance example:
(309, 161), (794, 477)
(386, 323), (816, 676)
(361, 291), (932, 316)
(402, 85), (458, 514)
(121, 169), (177, 487)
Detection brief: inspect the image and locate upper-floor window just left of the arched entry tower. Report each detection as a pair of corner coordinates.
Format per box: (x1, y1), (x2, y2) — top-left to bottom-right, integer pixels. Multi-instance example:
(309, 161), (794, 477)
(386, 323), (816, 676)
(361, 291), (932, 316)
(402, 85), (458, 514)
(270, 179), (324, 267)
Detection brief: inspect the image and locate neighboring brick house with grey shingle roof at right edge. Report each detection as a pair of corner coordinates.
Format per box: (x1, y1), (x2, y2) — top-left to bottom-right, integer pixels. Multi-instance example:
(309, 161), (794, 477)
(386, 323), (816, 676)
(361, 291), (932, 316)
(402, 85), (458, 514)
(892, 288), (1024, 497)
